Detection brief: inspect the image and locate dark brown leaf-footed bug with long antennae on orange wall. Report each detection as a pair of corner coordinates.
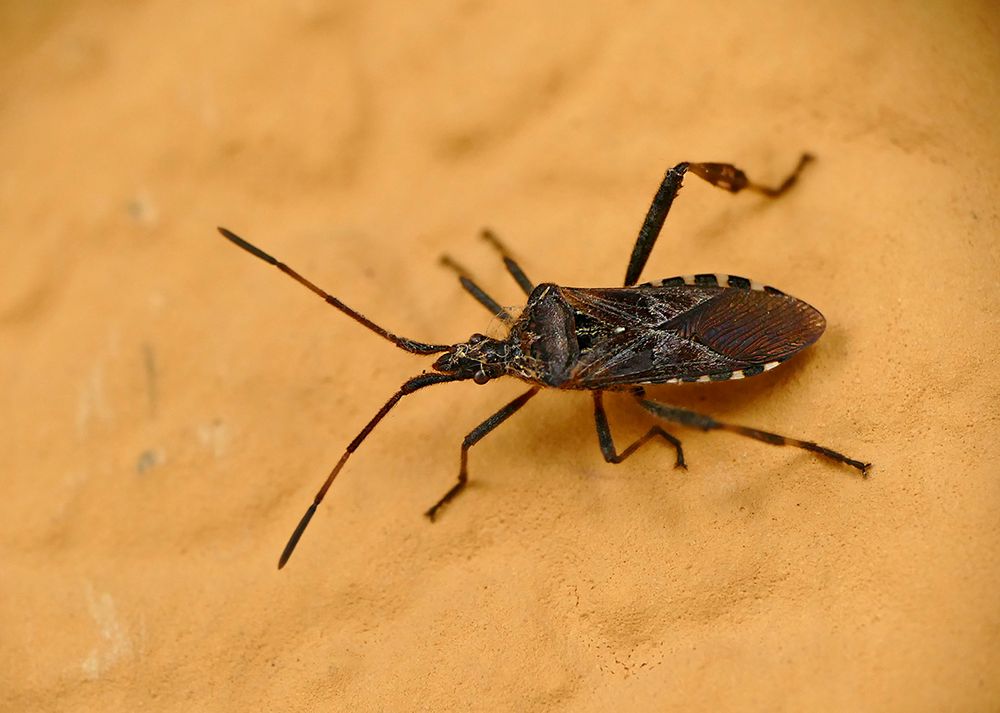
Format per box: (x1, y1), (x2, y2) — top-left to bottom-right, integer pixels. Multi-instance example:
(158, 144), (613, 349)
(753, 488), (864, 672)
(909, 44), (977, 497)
(219, 154), (871, 569)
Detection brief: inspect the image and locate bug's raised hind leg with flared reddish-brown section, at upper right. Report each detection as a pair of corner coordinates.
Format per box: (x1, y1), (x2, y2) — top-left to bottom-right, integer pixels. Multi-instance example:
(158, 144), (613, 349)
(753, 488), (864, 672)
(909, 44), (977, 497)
(625, 153), (813, 287)
